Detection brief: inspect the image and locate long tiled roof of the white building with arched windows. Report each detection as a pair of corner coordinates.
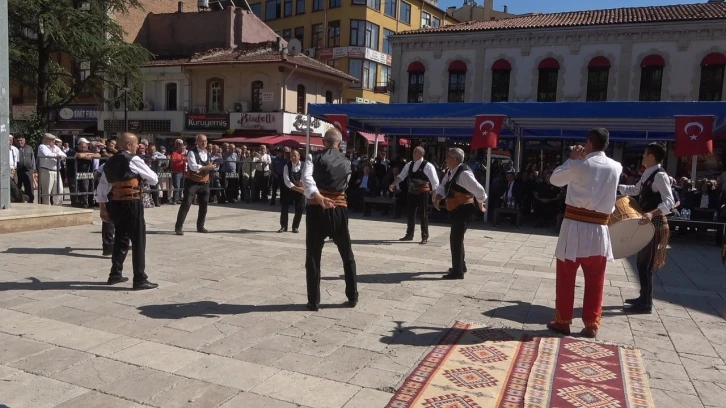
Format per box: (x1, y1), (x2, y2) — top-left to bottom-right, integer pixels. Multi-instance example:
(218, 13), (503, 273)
(399, 3), (726, 34)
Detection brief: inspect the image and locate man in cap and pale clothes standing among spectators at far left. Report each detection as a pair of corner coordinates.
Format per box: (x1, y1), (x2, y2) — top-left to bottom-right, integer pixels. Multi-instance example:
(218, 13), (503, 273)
(38, 133), (66, 205)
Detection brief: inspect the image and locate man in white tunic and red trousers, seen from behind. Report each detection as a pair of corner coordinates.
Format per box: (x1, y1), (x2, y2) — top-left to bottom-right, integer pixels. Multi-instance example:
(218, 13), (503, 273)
(547, 128), (623, 338)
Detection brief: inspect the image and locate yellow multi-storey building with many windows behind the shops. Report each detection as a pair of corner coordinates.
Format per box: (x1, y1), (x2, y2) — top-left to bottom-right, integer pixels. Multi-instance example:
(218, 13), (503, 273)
(256, 0), (458, 103)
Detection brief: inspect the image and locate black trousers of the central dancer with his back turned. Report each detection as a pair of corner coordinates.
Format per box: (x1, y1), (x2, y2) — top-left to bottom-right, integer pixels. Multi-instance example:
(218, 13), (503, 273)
(305, 205), (358, 305)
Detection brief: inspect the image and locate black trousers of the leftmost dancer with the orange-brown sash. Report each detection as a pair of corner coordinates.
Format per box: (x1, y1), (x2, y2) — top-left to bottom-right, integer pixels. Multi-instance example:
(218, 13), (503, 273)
(107, 200), (148, 283)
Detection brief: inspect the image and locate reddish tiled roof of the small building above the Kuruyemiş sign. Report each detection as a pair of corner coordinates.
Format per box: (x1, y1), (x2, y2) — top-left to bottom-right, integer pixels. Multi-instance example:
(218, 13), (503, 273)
(146, 44), (358, 82)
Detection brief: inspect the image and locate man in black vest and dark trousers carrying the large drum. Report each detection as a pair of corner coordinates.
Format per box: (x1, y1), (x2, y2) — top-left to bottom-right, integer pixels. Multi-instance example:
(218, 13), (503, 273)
(618, 143), (675, 314)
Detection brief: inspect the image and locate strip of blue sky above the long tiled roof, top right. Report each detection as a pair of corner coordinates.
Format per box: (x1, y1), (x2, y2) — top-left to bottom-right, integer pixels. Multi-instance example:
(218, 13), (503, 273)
(439, 0), (706, 14)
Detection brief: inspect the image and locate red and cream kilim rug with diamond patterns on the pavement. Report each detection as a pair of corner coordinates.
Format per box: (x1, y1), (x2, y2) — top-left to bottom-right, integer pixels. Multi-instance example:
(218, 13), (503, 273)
(386, 322), (655, 408)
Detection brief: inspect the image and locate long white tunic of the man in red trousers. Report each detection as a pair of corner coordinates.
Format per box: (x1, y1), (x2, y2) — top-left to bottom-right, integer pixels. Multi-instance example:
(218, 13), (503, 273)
(550, 152), (623, 261)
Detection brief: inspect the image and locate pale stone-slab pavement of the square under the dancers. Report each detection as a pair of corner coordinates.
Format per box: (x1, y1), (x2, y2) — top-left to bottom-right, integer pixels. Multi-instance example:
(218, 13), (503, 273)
(0, 205), (726, 408)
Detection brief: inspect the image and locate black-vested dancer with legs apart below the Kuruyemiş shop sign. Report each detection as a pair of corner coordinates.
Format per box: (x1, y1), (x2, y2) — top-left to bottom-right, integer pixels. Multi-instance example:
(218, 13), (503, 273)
(174, 134), (216, 235)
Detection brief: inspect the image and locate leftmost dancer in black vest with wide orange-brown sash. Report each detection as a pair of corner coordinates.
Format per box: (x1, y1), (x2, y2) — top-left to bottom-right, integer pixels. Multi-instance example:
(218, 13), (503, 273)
(96, 133), (159, 289)
